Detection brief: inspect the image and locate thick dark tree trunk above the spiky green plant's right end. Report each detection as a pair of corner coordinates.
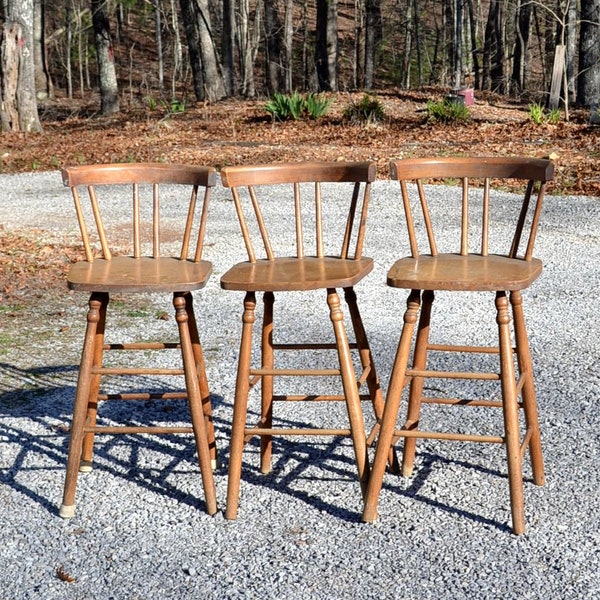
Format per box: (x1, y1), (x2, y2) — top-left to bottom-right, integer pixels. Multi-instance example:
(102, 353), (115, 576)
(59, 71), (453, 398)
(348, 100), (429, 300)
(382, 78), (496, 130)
(316, 0), (338, 92)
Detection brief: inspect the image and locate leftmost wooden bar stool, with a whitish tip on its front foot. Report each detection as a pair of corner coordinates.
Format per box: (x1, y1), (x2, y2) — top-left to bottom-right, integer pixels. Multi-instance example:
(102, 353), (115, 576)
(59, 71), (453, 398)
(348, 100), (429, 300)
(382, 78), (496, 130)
(60, 164), (217, 518)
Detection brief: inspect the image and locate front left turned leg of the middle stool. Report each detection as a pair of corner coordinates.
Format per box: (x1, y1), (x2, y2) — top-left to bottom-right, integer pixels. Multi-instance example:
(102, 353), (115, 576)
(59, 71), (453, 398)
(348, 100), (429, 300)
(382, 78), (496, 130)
(225, 292), (256, 520)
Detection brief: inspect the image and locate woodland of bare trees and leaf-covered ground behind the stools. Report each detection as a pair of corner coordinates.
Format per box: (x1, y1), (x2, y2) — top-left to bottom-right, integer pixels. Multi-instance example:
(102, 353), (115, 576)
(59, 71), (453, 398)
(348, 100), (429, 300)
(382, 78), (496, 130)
(0, 0), (600, 195)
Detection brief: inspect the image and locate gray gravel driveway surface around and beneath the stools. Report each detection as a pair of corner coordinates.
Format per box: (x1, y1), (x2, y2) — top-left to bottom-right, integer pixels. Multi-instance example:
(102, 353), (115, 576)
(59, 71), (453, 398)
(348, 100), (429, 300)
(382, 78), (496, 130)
(0, 173), (600, 600)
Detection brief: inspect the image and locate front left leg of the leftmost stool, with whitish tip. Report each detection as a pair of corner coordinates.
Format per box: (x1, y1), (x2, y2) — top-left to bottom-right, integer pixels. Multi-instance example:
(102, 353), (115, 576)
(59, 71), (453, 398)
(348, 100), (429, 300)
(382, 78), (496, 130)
(59, 293), (106, 519)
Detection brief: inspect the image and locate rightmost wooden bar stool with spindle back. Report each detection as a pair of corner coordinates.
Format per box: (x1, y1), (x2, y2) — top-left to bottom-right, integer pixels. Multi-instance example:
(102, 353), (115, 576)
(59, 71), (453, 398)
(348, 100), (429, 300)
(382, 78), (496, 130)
(363, 158), (554, 534)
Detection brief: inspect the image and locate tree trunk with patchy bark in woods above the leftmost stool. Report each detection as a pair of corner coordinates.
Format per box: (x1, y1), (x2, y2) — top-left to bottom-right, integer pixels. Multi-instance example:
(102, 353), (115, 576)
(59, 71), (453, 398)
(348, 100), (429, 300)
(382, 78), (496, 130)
(92, 0), (119, 115)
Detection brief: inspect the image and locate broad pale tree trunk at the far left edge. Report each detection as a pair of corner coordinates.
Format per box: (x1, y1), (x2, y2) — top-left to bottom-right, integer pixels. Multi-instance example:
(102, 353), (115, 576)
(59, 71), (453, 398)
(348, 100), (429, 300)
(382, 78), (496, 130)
(0, 0), (42, 132)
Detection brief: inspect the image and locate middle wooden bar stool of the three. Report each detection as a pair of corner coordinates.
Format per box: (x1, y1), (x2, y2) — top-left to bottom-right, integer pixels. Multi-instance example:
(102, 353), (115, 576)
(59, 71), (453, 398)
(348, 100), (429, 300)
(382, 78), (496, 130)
(221, 162), (392, 519)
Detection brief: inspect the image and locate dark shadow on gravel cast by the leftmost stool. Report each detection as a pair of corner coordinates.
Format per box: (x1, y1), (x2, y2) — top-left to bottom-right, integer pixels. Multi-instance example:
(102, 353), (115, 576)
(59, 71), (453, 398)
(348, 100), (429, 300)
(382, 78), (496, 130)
(0, 363), (228, 514)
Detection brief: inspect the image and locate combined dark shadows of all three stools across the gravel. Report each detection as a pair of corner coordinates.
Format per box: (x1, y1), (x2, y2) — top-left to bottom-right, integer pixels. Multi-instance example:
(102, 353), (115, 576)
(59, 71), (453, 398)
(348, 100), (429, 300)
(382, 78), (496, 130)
(0, 363), (509, 531)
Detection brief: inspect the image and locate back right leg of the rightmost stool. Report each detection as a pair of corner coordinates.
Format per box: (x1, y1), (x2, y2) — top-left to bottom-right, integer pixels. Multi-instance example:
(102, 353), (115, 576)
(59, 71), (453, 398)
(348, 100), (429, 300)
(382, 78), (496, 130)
(510, 292), (546, 485)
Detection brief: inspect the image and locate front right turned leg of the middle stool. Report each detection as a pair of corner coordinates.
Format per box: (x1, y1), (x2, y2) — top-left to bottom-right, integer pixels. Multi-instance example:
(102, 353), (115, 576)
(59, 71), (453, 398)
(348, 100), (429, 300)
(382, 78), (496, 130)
(327, 288), (369, 498)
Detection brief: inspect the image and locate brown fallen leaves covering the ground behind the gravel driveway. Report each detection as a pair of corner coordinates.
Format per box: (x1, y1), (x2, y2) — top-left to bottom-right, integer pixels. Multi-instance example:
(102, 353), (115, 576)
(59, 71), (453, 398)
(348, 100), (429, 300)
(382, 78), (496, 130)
(0, 89), (600, 304)
